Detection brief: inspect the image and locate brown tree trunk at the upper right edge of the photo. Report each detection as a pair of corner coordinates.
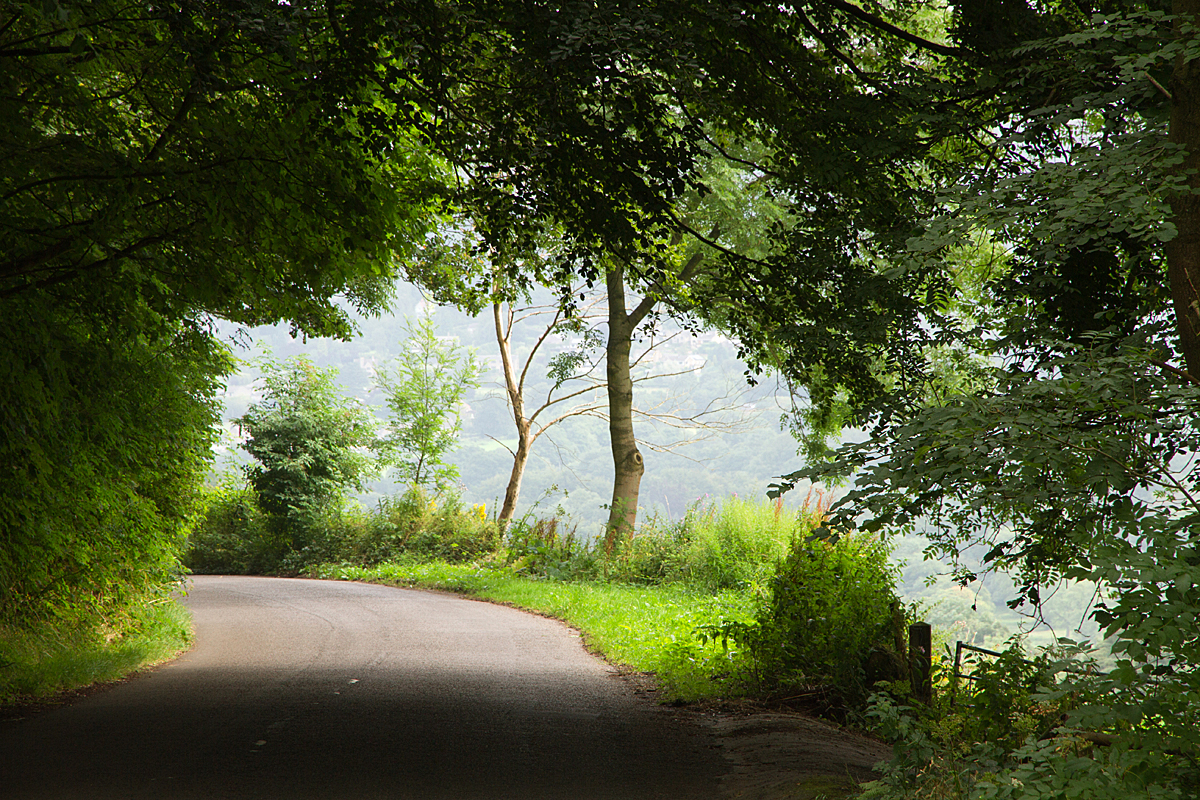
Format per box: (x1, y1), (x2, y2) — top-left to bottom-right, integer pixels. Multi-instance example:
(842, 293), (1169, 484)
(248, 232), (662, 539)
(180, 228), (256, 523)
(1166, 0), (1200, 378)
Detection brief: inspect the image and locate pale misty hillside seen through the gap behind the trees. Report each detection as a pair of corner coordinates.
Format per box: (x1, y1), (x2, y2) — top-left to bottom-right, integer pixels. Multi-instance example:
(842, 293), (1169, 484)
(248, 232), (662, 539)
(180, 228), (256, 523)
(218, 278), (803, 536)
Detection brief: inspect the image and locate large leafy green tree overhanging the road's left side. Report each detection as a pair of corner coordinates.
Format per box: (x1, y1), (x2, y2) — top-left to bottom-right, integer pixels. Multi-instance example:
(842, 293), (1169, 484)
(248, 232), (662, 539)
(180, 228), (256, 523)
(0, 0), (441, 624)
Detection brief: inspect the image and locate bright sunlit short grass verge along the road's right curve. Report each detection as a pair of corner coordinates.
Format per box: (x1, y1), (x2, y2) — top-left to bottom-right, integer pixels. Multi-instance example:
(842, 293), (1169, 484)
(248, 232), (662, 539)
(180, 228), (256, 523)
(310, 561), (755, 700)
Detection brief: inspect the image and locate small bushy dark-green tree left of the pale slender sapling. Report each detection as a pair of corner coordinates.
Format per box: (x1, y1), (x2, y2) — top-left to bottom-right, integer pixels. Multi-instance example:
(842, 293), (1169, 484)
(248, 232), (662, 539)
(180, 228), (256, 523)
(238, 356), (374, 549)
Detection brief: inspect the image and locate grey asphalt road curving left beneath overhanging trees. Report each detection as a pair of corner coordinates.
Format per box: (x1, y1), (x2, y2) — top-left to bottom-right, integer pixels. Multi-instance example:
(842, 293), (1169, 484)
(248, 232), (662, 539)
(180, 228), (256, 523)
(0, 577), (721, 800)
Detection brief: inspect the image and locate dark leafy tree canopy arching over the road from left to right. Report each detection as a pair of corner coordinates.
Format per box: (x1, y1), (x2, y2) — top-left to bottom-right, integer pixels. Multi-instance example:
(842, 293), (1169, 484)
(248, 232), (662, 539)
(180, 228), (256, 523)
(7, 0), (1200, 796)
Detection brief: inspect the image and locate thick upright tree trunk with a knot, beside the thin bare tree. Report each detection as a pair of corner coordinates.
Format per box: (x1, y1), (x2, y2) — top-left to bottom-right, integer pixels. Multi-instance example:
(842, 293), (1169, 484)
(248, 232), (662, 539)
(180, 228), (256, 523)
(605, 266), (649, 553)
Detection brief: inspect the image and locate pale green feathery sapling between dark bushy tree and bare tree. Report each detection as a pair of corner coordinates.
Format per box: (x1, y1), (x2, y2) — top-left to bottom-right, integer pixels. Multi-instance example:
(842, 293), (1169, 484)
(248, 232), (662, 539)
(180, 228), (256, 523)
(376, 312), (480, 489)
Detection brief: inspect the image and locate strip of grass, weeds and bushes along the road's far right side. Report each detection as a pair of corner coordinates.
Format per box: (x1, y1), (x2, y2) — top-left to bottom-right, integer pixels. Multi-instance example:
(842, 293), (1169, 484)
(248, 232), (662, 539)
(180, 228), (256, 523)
(185, 485), (912, 718)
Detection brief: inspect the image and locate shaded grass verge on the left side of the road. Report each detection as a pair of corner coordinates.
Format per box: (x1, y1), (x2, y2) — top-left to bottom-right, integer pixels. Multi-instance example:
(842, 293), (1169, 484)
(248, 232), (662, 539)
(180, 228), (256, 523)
(0, 600), (192, 708)
